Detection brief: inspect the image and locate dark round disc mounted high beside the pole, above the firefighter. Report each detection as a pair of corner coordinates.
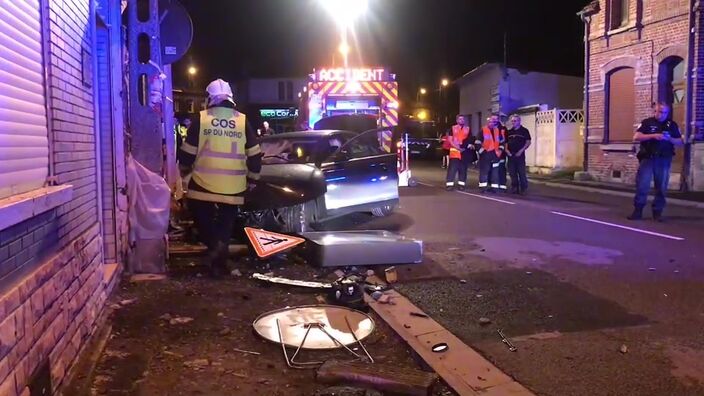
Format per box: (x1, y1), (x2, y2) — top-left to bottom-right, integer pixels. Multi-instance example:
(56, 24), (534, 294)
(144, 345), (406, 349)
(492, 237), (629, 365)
(159, 0), (193, 65)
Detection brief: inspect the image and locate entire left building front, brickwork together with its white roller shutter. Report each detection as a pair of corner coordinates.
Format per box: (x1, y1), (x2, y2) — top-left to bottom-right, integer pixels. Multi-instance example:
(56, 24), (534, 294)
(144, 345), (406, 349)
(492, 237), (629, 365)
(0, 0), (126, 396)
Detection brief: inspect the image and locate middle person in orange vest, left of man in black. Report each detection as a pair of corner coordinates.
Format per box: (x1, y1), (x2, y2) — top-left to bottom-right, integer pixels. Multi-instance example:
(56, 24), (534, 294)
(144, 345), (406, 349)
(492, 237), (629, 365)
(475, 114), (506, 192)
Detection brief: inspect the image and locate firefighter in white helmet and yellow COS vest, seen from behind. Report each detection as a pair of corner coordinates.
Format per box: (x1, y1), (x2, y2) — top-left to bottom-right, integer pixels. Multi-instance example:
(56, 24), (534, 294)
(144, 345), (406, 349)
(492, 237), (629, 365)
(179, 79), (262, 277)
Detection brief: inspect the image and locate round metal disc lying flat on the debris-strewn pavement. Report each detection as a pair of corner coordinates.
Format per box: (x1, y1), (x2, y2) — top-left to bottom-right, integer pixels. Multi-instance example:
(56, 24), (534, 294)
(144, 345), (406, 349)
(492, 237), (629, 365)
(252, 305), (374, 349)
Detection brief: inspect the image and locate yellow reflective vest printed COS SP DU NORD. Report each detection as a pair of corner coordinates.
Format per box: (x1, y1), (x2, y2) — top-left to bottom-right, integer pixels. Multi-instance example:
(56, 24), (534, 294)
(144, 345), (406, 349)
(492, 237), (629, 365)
(193, 107), (247, 195)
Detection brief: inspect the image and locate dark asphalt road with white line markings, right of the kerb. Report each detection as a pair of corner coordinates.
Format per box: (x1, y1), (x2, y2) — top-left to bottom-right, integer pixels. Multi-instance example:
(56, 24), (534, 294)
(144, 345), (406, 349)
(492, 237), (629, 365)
(325, 163), (704, 396)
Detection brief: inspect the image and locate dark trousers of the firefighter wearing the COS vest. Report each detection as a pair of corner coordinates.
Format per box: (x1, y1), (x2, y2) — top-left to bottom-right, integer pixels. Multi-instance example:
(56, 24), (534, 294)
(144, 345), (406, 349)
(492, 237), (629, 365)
(188, 199), (239, 265)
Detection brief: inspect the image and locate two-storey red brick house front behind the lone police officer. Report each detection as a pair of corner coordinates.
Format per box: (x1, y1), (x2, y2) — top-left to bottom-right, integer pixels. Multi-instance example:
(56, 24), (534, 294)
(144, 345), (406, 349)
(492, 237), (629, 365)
(583, 0), (704, 190)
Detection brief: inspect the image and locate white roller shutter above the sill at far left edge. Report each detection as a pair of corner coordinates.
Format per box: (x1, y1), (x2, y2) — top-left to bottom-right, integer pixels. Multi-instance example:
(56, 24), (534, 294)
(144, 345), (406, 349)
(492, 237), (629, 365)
(0, 0), (49, 198)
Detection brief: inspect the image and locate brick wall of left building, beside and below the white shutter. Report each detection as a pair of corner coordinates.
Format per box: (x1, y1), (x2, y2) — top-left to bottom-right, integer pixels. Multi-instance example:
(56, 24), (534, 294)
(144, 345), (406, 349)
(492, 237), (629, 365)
(0, 0), (115, 396)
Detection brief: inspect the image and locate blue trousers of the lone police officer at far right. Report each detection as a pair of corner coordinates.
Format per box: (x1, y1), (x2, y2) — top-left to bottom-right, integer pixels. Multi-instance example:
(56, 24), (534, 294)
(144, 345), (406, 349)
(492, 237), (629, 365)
(633, 157), (672, 212)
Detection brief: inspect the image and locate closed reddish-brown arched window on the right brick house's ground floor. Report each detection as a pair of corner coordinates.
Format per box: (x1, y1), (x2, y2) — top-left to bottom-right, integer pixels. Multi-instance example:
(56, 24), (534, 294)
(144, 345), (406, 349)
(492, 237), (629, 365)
(606, 67), (636, 143)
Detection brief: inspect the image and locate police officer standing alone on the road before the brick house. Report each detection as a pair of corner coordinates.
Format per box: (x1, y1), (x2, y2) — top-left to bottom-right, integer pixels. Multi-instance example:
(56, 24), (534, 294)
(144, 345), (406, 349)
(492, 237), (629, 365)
(628, 103), (683, 222)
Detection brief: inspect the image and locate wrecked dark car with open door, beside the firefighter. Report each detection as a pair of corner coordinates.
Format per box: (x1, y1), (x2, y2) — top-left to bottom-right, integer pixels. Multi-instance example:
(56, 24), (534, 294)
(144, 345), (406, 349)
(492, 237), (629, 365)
(244, 128), (399, 233)
